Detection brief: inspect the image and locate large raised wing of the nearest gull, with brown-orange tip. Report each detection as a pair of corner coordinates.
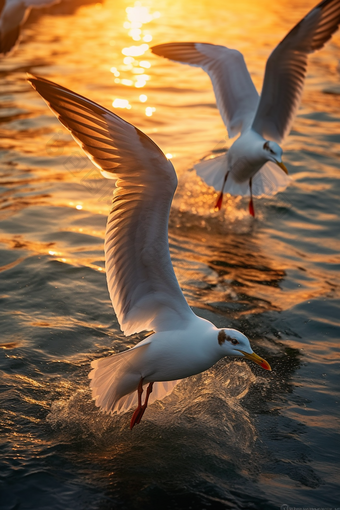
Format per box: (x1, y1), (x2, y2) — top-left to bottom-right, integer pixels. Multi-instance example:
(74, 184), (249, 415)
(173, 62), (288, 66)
(29, 77), (193, 335)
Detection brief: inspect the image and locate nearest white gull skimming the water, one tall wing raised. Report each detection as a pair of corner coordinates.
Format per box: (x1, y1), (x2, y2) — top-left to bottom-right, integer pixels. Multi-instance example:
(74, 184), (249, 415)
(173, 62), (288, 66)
(28, 75), (271, 429)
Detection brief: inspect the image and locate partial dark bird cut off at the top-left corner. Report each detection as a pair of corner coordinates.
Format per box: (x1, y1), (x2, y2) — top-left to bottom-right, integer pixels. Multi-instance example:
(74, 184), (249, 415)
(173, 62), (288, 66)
(0, 0), (61, 56)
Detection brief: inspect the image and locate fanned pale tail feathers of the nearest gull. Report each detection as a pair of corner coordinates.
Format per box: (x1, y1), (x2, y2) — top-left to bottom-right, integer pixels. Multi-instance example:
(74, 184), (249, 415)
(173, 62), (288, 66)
(89, 343), (179, 414)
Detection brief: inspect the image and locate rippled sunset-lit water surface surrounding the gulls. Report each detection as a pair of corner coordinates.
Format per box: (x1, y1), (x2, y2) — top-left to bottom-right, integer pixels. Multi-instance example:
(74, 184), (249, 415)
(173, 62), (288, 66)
(0, 0), (340, 510)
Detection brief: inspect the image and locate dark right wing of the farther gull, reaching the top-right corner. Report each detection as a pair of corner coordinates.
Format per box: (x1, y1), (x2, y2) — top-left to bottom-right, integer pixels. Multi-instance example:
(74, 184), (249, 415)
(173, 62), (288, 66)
(252, 0), (340, 143)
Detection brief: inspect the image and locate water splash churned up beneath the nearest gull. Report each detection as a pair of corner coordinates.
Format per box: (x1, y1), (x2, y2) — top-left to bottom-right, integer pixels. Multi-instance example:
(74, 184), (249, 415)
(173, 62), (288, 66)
(46, 362), (257, 453)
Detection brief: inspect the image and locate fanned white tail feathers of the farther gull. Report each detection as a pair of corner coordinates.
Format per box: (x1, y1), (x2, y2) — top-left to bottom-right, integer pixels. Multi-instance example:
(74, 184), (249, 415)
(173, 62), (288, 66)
(194, 154), (290, 198)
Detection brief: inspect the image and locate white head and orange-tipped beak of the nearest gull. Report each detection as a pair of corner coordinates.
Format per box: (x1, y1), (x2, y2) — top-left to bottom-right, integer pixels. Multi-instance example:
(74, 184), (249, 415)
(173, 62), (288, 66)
(217, 328), (271, 370)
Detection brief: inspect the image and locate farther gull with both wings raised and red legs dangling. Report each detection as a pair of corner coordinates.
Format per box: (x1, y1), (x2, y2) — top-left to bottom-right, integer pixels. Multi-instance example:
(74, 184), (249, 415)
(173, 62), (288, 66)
(151, 0), (340, 216)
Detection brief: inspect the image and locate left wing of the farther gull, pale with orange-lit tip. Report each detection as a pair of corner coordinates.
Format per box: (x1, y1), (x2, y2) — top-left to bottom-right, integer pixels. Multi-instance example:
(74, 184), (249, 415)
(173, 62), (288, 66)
(151, 42), (259, 138)
